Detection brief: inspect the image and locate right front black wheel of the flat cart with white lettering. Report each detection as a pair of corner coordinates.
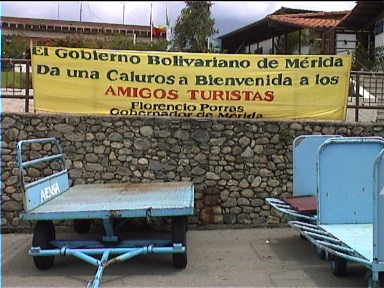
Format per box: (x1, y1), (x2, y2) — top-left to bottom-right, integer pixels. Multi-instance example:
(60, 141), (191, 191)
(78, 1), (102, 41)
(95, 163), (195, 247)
(172, 216), (187, 269)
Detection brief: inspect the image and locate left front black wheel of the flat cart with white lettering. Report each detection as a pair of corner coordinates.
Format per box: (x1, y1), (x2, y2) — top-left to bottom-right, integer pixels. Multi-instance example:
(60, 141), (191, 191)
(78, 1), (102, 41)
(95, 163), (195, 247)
(32, 221), (56, 270)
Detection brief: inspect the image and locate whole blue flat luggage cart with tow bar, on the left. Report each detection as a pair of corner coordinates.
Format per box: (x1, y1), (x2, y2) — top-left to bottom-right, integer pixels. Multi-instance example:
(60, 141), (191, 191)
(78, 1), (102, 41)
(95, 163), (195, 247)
(16, 138), (194, 287)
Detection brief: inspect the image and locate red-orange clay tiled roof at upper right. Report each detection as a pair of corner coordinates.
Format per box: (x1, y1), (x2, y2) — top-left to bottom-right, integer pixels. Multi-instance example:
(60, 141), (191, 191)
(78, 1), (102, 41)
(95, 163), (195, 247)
(268, 10), (351, 29)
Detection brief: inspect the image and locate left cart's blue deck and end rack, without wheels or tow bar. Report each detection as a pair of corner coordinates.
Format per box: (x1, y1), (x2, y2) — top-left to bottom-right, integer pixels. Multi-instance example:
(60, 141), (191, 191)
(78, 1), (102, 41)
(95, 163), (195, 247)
(17, 138), (194, 220)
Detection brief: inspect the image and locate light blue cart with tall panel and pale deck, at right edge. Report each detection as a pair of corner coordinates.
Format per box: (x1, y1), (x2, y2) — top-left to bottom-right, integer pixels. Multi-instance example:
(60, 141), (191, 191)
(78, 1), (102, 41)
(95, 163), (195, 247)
(288, 138), (384, 287)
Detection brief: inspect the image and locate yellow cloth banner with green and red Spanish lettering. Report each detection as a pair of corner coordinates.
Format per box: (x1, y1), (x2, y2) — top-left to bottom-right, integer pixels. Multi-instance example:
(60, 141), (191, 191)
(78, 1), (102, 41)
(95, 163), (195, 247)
(32, 46), (352, 120)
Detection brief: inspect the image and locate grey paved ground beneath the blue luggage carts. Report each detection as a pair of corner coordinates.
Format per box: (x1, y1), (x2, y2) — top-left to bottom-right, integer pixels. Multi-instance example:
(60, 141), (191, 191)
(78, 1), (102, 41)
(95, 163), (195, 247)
(2, 228), (367, 288)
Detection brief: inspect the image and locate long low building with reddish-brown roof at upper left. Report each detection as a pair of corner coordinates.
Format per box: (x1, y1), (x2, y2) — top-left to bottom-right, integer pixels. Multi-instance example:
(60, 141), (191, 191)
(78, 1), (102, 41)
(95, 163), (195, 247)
(0, 16), (166, 43)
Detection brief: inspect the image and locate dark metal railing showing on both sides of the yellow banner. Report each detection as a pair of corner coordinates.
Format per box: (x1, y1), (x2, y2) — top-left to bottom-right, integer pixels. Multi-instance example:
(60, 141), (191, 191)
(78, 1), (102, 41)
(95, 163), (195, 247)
(0, 59), (384, 122)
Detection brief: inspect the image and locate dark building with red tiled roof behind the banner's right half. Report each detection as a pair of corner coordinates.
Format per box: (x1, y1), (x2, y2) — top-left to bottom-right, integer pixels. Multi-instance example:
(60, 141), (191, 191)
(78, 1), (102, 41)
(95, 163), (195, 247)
(219, 7), (356, 54)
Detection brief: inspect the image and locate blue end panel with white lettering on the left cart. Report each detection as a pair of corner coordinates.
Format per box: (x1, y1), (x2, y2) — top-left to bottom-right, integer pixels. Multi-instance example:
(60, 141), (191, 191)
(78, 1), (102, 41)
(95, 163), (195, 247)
(24, 170), (69, 211)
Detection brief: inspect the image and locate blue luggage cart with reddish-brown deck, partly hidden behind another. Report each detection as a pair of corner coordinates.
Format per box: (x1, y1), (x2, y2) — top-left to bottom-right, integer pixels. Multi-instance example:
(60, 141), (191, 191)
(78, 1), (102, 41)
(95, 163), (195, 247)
(265, 135), (341, 223)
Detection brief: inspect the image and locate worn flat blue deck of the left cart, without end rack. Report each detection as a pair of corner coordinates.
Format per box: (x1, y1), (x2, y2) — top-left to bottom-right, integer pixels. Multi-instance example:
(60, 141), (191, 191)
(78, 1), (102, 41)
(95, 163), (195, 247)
(23, 182), (194, 220)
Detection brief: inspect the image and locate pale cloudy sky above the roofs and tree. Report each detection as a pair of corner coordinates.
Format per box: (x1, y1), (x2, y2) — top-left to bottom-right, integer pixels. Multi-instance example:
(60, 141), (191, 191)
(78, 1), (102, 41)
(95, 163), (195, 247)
(1, 1), (356, 36)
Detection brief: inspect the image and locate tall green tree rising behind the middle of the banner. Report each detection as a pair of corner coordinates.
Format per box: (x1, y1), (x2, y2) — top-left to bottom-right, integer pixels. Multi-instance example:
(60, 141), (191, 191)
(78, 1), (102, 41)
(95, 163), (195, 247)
(172, 1), (218, 52)
